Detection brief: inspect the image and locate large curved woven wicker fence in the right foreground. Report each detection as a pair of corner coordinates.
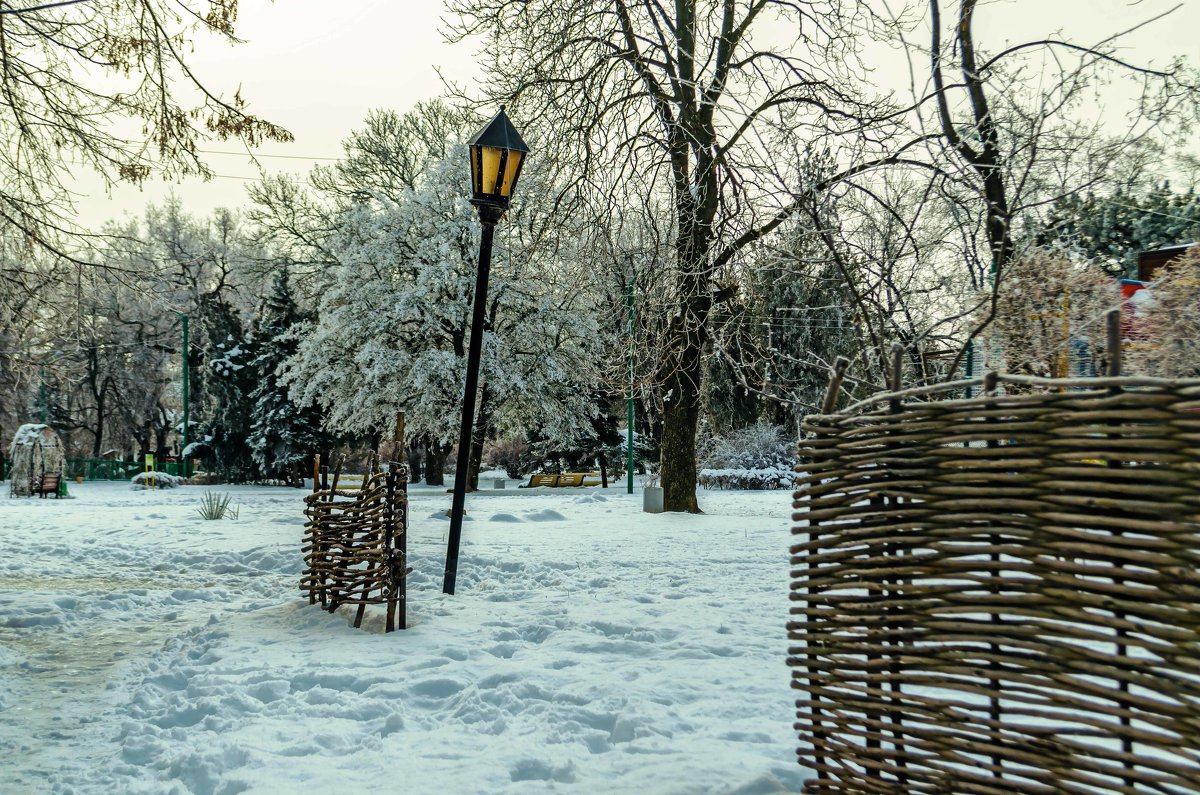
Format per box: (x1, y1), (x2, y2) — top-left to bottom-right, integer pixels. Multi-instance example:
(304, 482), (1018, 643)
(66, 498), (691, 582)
(788, 376), (1200, 795)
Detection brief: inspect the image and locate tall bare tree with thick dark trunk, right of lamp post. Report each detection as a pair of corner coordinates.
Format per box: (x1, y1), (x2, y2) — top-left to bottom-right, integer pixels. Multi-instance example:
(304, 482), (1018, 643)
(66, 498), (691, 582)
(450, 0), (916, 512)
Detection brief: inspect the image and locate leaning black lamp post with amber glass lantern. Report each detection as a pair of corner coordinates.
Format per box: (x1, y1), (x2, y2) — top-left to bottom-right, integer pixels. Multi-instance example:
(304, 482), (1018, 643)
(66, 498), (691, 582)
(442, 104), (529, 593)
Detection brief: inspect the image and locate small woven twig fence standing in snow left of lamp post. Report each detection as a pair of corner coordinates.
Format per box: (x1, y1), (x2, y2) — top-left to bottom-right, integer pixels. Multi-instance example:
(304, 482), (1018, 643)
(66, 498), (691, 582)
(300, 455), (412, 632)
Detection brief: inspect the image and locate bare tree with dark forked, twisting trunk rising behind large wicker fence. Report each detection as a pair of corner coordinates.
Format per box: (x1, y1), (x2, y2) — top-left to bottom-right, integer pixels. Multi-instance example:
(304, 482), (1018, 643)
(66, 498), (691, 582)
(910, 0), (1200, 373)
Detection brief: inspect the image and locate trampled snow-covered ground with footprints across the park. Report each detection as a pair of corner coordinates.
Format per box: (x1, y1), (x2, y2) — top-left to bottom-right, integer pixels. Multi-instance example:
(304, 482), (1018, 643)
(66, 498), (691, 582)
(0, 480), (804, 795)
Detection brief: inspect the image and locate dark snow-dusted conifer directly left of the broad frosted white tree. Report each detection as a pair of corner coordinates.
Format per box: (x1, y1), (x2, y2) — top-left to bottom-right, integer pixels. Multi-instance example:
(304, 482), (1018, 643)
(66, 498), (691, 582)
(248, 269), (331, 485)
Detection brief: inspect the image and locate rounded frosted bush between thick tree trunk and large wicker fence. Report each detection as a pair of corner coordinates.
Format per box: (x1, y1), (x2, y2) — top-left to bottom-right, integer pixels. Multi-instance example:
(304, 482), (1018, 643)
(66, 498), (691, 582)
(698, 423), (796, 489)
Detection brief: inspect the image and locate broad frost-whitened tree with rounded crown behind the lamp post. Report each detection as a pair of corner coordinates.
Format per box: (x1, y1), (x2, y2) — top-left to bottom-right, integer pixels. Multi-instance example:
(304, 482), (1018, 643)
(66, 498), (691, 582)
(283, 145), (600, 489)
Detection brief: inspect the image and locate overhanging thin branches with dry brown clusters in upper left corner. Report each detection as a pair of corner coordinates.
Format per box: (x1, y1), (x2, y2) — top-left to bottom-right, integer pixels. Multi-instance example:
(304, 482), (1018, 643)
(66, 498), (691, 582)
(0, 0), (292, 253)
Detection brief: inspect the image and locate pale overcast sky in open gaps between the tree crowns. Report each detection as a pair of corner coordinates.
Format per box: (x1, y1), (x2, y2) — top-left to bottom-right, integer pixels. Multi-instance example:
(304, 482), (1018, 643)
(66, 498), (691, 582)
(68, 0), (1200, 225)
